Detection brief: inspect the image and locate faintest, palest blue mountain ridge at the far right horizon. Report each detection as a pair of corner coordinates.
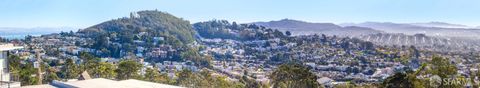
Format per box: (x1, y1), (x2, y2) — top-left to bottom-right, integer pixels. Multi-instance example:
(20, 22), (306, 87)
(341, 22), (480, 38)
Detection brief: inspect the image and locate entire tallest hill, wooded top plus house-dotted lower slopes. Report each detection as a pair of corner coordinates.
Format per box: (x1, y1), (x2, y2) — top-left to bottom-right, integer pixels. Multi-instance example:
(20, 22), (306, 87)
(72, 10), (196, 58)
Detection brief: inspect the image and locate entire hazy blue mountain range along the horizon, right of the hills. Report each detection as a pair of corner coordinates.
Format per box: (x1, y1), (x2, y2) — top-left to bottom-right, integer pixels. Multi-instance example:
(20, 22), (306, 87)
(251, 19), (480, 39)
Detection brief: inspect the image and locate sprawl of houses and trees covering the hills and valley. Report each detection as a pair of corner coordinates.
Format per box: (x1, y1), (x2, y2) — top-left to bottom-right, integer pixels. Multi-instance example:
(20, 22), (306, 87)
(0, 10), (480, 88)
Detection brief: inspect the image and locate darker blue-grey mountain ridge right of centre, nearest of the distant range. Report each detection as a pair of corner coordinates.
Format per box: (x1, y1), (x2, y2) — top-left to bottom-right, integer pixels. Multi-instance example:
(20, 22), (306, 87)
(250, 19), (382, 36)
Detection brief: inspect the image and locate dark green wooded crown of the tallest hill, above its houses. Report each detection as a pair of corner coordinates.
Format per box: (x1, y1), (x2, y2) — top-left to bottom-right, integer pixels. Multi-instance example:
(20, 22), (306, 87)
(79, 10), (195, 43)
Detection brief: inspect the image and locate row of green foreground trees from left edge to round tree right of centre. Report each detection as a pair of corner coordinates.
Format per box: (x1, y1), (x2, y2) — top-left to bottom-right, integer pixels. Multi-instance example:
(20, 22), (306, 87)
(9, 53), (326, 88)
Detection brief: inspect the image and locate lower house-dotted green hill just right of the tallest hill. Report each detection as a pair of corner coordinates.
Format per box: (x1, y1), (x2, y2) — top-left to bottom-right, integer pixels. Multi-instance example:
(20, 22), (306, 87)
(193, 20), (285, 40)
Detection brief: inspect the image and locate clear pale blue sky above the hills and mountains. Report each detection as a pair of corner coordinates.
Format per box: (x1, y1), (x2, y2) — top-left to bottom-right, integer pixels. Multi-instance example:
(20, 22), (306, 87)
(0, 0), (480, 28)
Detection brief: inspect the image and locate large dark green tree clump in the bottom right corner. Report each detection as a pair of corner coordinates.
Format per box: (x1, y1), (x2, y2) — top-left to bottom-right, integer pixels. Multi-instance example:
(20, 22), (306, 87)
(382, 56), (472, 88)
